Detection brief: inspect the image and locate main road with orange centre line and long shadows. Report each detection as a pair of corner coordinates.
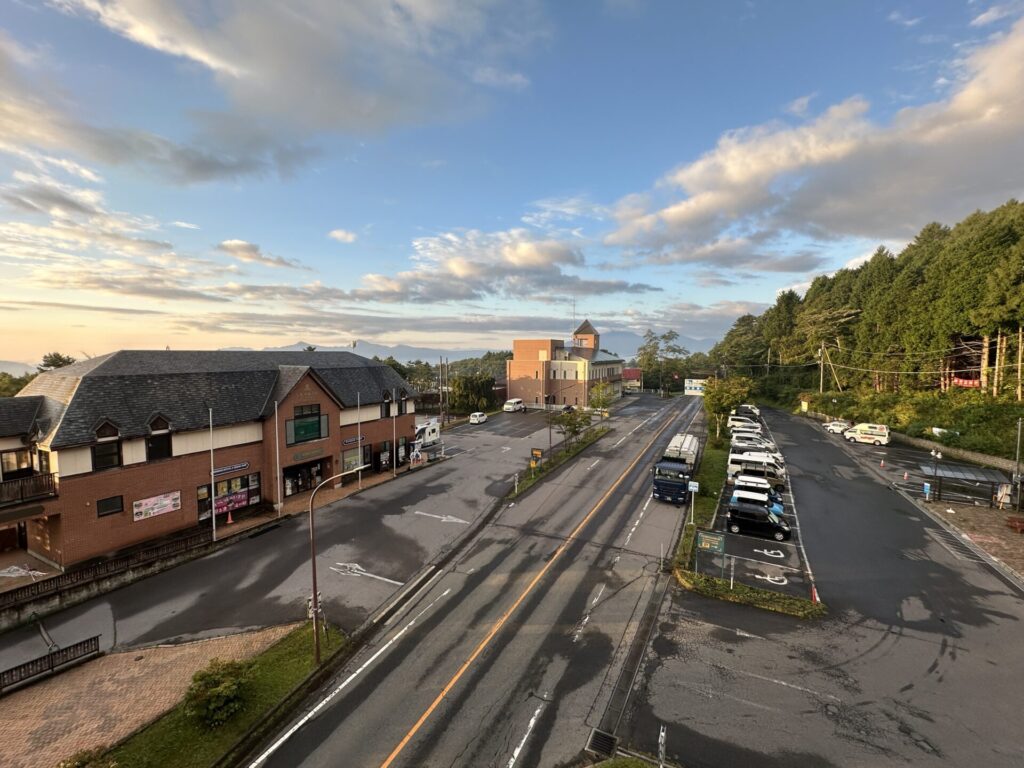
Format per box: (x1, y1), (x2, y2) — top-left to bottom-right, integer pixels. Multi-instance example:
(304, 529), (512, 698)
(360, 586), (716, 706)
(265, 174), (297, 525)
(250, 397), (699, 768)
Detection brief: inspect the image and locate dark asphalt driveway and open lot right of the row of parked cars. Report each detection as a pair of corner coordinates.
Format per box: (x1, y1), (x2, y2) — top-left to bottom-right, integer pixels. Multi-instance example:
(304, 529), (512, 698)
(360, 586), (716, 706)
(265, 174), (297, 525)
(621, 413), (1024, 768)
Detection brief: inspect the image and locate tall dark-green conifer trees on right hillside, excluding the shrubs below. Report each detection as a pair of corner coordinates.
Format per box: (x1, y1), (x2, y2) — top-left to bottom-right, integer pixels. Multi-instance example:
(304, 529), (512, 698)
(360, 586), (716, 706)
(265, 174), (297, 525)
(709, 201), (1024, 398)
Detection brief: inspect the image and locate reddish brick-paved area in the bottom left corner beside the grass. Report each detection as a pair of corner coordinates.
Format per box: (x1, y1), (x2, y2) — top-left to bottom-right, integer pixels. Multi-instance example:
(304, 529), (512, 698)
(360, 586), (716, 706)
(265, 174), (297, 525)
(0, 625), (296, 768)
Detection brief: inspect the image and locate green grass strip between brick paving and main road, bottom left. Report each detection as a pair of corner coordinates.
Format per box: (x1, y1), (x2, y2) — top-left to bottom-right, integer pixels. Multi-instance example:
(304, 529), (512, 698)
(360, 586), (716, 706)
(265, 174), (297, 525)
(109, 623), (346, 768)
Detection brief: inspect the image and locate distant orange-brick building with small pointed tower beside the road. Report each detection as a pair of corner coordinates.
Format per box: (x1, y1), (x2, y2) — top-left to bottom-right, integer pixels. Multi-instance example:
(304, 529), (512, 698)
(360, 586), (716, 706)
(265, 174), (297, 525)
(506, 321), (624, 408)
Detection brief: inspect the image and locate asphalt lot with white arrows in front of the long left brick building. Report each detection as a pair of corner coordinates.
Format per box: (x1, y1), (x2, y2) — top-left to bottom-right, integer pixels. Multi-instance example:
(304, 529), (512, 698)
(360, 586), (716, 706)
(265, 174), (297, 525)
(0, 412), (569, 669)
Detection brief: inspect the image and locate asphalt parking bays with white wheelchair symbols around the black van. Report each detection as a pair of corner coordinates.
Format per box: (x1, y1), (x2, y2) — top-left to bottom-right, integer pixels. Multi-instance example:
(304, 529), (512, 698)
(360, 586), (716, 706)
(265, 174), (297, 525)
(694, 415), (813, 598)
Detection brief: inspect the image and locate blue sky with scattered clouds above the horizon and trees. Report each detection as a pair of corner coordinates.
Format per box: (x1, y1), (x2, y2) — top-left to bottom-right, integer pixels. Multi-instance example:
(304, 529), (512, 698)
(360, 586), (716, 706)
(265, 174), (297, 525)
(0, 0), (1024, 362)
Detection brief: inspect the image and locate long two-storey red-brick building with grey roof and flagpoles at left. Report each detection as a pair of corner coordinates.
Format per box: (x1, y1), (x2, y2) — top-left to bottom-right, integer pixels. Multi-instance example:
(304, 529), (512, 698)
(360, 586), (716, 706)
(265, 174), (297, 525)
(0, 351), (416, 566)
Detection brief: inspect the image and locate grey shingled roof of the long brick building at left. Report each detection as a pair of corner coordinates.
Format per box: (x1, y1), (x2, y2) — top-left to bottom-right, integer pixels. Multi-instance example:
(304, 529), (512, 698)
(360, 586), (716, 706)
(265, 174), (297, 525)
(24, 350), (417, 449)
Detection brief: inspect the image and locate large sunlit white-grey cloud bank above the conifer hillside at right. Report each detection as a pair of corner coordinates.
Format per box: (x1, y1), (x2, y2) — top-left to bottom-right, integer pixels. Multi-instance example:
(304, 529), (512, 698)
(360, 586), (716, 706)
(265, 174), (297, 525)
(606, 20), (1024, 268)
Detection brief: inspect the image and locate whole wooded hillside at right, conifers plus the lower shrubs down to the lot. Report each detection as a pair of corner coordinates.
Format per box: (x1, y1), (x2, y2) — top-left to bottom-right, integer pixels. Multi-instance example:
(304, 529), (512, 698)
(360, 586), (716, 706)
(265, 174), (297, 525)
(708, 201), (1024, 457)
